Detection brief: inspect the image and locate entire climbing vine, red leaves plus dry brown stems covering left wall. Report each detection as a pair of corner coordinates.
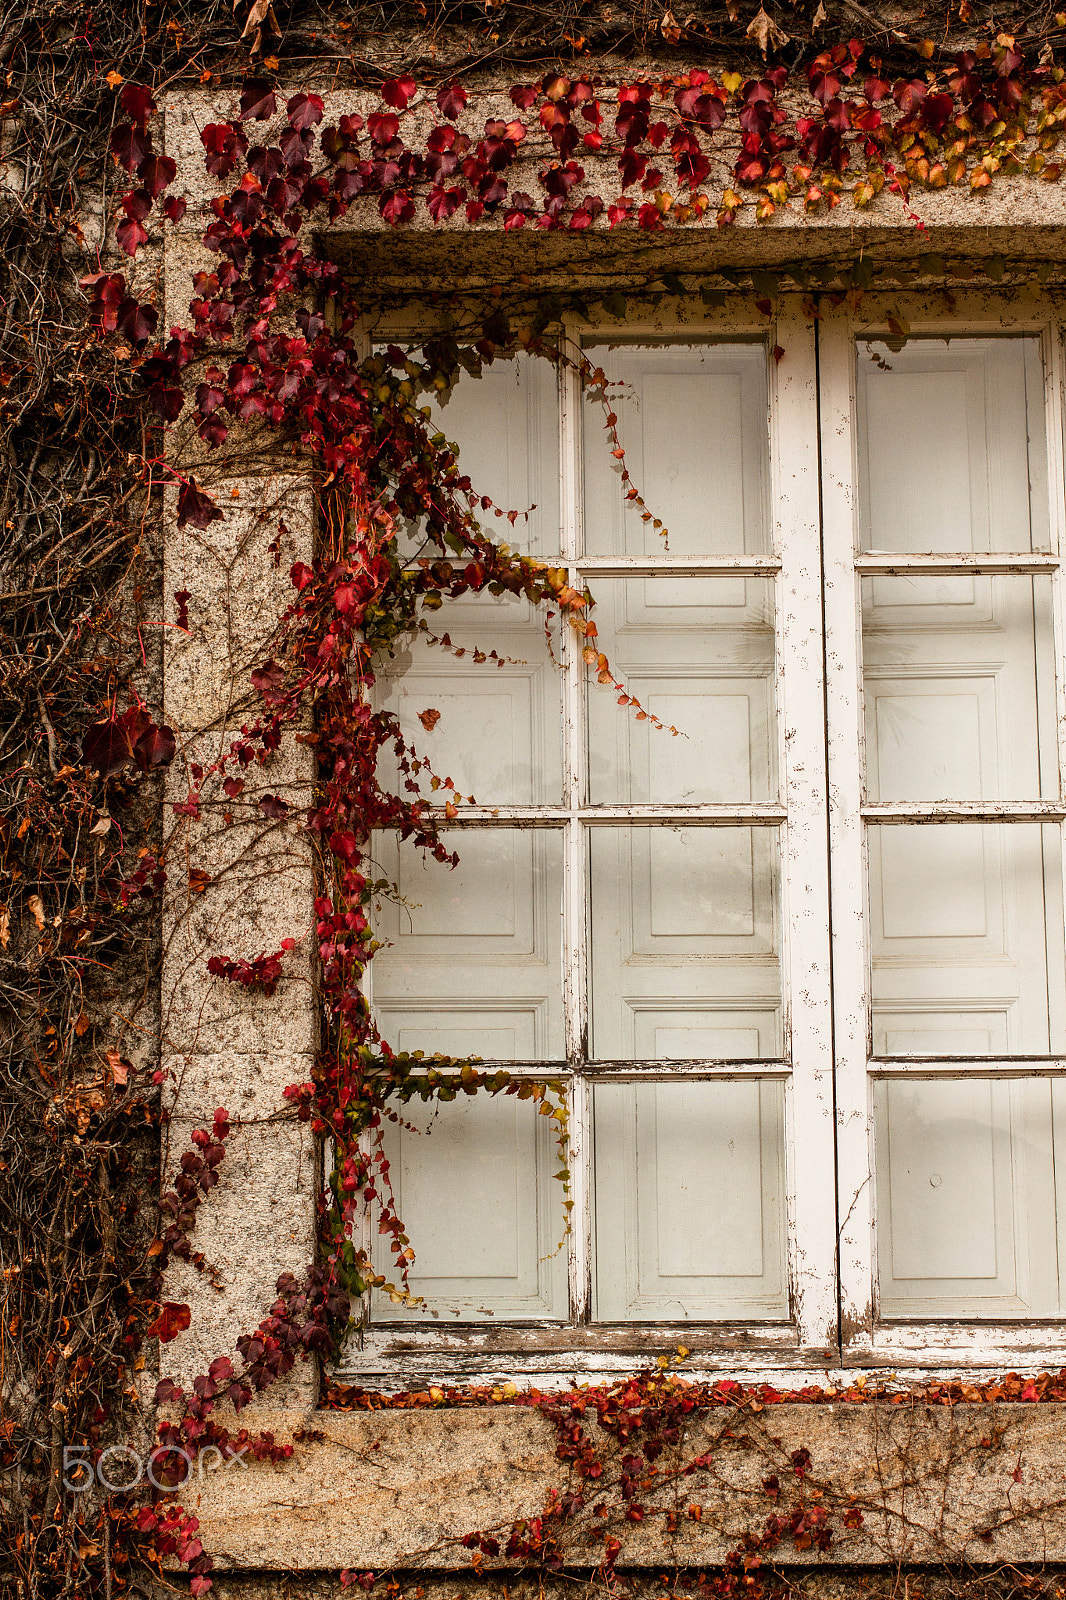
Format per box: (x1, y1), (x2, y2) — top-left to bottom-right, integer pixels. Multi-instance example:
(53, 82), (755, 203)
(10, 3), (1066, 1595)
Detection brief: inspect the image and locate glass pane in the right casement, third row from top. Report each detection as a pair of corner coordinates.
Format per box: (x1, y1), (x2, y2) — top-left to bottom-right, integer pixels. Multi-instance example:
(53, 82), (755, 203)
(869, 822), (1066, 1058)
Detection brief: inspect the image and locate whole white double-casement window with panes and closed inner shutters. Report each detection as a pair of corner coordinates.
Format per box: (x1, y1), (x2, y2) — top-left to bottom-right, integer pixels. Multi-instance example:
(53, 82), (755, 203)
(337, 296), (1066, 1376)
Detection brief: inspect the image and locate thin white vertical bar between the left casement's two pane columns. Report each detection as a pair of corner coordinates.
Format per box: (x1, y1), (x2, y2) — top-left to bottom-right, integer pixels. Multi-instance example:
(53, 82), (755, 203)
(559, 318), (592, 1323)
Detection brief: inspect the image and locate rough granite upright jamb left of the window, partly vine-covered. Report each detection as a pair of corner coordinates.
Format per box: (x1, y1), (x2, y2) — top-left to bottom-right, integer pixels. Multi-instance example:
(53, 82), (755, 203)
(162, 475), (317, 1408)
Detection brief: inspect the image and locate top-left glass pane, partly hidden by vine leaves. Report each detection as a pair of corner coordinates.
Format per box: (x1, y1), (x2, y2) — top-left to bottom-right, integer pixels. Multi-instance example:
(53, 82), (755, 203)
(398, 355), (559, 560)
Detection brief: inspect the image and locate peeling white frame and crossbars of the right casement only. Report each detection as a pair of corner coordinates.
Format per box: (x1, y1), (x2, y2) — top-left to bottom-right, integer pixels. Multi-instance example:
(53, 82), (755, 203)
(820, 291), (1066, 1368)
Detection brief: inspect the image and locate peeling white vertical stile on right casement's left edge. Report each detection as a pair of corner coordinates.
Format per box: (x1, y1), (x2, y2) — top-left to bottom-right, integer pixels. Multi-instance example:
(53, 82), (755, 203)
(818, 297), (874, 1362)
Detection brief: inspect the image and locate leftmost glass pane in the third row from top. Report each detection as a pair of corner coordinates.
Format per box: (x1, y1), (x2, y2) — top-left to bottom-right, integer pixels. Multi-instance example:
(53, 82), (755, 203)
(370, 827), (565, 1061)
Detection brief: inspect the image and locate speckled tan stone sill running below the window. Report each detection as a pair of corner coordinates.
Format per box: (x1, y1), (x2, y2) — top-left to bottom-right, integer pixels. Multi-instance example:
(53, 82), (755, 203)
(174, 1403), (1066, 1573)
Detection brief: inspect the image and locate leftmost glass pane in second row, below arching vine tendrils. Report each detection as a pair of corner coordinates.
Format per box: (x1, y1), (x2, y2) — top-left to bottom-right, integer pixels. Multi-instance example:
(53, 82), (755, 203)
(378, 595), (563, 805)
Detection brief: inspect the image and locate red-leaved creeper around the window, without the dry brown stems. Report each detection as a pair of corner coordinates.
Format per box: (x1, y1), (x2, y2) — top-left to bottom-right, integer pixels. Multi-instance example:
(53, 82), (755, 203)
(10, 8), (1066, 1594)
